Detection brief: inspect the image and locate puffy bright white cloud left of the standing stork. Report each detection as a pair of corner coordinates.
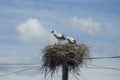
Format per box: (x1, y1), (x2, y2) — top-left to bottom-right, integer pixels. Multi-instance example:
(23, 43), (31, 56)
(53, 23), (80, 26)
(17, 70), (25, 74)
(16, 18), (54, 43)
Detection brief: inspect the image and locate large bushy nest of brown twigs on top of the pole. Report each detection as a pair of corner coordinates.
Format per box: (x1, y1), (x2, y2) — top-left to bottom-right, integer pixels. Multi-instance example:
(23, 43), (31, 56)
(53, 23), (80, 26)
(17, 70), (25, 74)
(42, 44), (89, 72)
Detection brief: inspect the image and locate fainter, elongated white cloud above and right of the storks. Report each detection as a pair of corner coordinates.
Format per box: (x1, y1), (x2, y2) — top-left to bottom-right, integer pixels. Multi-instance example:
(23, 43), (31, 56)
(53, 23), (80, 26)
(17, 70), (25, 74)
(69, 17), (101, 35)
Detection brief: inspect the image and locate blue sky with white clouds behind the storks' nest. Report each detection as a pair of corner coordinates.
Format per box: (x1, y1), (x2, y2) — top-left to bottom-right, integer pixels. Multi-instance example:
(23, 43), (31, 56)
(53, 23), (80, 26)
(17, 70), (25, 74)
(0, 0), (120, 80)
